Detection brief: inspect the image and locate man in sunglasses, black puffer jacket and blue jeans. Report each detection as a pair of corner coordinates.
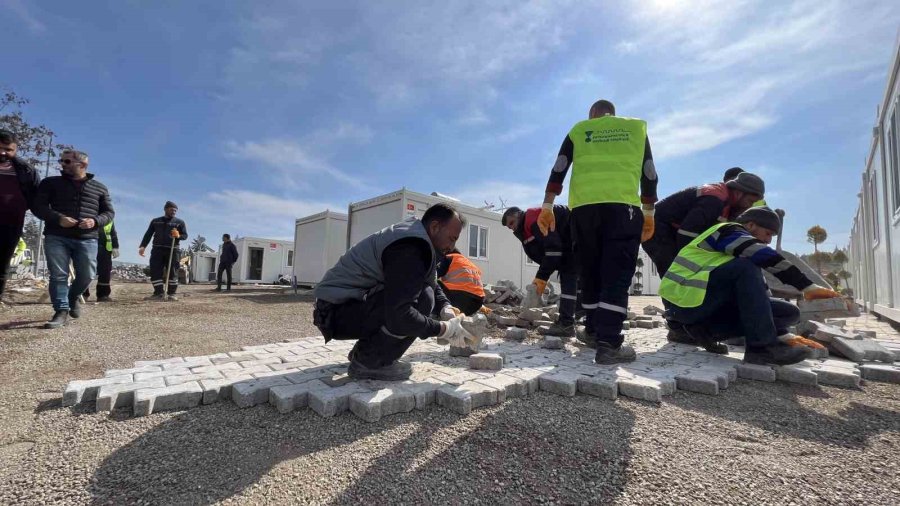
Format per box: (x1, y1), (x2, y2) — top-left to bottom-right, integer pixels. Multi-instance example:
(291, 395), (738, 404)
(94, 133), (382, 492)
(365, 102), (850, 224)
(32, 149), (115, 329)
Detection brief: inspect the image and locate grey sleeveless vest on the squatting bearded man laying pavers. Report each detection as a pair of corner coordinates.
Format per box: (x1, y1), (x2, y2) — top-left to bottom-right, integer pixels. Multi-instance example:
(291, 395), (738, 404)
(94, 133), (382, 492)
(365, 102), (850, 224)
(313, 218), (437, 304)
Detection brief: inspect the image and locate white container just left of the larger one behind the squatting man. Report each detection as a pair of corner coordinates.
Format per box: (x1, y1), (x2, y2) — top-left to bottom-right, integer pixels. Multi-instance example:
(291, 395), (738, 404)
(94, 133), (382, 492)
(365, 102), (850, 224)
(293, 210), (347, 286)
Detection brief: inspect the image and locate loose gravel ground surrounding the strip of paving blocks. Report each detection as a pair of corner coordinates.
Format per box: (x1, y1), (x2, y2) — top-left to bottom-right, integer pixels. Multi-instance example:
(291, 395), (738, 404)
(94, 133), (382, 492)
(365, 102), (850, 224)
(0, 285), (900, 505)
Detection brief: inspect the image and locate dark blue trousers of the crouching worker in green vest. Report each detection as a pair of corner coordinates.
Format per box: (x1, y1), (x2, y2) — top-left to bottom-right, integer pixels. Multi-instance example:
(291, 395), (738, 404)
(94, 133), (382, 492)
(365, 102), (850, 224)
(666, 258), (800, 348)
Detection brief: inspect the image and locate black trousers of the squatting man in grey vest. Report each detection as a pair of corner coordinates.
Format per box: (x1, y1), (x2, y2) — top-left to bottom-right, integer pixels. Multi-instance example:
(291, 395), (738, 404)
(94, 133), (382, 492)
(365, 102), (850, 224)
(331, 285), (434, 368)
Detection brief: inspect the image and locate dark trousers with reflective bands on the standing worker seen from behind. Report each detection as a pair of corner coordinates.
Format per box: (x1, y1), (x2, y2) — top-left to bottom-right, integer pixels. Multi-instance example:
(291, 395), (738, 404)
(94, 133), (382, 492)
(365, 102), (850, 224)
(571, 204), (644, 348)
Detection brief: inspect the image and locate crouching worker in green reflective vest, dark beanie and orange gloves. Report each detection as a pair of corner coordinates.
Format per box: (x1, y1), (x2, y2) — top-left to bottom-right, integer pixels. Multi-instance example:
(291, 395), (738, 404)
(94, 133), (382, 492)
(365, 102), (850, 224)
(659, 207), (840, 365)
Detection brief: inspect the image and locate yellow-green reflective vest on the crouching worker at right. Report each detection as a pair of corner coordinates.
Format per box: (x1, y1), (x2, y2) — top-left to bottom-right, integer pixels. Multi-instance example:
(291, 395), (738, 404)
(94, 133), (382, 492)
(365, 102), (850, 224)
(659, 222), (734, 307)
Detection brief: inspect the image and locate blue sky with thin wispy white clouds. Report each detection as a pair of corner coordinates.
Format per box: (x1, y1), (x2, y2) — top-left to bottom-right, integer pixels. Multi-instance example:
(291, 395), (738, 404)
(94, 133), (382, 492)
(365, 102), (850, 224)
(7, 0), (900, 262)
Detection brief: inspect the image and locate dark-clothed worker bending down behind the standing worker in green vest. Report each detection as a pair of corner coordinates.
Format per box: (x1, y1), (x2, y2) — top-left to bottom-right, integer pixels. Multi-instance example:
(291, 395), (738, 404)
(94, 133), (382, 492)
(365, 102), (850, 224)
(502, 205), (580, 337)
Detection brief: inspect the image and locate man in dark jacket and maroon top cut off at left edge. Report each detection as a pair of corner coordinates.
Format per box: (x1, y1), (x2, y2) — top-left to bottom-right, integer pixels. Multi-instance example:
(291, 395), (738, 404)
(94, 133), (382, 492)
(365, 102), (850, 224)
(0, 130), (40, 307)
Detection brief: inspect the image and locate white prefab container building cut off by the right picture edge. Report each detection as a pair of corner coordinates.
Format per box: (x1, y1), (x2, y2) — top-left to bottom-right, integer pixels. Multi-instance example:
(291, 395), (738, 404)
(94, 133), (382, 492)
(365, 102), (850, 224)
(847, 33), (900, 323)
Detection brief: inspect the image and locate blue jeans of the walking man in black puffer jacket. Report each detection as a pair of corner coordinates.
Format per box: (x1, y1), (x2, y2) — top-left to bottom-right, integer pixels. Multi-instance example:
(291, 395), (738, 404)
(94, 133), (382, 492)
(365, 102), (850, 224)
(44, 235), (97, 311)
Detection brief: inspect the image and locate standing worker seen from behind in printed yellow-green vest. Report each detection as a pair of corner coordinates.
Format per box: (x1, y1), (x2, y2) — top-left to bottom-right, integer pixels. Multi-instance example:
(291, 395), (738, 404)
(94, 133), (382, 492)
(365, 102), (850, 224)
(538, 100), (658, 364)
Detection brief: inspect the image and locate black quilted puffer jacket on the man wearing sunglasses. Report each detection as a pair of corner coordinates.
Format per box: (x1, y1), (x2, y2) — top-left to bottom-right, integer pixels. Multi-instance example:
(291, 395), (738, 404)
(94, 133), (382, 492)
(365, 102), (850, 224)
(31, 174), (116, 239)
